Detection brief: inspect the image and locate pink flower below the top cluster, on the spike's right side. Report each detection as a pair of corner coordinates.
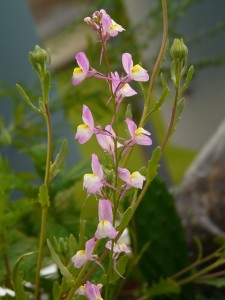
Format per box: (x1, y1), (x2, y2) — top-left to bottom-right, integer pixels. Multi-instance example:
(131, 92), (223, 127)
(122, 53), (149, 81)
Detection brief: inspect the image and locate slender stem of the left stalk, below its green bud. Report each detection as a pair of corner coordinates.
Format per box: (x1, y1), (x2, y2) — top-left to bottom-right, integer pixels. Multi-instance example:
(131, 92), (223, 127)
(34, 103), (52, 300)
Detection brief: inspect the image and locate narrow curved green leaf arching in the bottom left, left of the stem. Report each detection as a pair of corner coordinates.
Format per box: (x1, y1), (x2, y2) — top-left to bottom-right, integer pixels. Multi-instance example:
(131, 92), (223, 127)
(12, 252), (38, 300)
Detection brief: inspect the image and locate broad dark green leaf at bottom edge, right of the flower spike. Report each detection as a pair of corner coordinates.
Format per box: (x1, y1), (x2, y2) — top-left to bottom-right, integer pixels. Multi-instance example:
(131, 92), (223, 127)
(145, 278), (180, 299)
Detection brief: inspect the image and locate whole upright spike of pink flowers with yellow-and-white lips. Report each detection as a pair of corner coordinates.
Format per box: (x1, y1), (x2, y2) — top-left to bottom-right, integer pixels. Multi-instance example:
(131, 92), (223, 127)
(71, 9), (152, 300)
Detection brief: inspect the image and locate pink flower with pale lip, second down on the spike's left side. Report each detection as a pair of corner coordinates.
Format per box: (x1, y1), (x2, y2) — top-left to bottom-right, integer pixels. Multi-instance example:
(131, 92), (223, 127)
(75, 105), (95, 144)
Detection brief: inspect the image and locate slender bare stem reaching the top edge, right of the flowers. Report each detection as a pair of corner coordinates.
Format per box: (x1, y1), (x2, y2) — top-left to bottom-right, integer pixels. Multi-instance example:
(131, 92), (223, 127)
(139, 0), (168, 127)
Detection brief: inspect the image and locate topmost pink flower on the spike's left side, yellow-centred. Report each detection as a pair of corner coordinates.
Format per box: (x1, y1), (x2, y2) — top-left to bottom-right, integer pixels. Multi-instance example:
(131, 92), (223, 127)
(72, 52), (90, 86)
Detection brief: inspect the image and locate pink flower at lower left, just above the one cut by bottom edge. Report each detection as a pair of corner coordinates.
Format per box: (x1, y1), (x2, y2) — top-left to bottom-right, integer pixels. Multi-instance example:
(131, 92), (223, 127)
(71, 238), (97, 269)
